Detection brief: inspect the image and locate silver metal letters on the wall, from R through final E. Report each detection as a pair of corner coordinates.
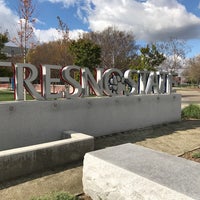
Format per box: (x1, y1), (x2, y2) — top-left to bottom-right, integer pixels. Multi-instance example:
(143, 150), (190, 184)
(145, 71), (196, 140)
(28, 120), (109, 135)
(14, 63), (176, 100)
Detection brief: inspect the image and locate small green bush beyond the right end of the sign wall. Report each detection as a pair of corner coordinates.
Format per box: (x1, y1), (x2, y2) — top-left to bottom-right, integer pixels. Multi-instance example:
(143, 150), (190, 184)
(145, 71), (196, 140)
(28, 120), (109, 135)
(181, 104), (200, 119)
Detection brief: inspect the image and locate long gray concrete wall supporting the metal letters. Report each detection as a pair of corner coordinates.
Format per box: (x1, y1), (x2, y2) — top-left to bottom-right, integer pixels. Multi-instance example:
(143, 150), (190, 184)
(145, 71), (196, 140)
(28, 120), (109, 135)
(0, 94), (181, 150)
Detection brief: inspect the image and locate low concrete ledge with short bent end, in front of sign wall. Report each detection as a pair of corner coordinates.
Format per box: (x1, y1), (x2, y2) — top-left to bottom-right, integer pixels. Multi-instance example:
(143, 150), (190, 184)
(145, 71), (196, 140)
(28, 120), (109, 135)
(0, 131), (94, 182)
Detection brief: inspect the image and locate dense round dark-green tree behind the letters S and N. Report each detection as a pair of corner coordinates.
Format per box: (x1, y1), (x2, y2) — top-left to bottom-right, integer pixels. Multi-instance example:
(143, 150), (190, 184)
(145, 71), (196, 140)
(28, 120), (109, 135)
(69, 38), (101, 69)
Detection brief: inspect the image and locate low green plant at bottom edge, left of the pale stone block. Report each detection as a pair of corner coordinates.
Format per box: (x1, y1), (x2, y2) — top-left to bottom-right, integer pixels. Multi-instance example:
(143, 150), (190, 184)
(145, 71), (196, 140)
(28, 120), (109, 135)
(31, 192), (78, 200)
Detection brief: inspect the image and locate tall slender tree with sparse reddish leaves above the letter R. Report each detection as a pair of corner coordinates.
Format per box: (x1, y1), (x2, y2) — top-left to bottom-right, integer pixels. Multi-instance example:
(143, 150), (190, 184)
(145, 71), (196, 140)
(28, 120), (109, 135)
(11, 0), (36, 63)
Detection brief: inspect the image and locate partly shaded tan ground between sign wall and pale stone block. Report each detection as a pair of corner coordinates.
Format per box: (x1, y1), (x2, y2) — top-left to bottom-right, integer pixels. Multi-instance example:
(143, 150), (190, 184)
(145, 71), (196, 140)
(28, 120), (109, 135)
(95, 120), (200, 155)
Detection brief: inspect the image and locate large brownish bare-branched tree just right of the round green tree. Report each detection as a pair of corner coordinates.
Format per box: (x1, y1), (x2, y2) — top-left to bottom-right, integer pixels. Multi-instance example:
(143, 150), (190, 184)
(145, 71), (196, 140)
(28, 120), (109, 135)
(84, 27), (138, 69)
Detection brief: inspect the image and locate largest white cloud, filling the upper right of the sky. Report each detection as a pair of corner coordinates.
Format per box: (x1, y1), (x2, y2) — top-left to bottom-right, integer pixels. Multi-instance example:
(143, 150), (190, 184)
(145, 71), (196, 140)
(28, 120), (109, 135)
(85, 0), (200, 41)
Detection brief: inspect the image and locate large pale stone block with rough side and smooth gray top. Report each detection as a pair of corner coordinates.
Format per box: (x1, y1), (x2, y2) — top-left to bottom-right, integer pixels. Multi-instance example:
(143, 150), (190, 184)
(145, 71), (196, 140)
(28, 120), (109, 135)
(83, 144), (200, 200)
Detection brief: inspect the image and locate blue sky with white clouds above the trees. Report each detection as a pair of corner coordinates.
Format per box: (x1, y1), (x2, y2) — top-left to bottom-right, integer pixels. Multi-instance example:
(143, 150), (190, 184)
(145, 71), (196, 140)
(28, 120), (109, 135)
(0, 0), (200, 57)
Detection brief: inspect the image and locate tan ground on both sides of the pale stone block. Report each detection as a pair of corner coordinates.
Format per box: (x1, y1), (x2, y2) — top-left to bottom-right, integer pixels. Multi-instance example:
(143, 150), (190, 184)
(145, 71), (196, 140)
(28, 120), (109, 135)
(0, 120), (200, 200)
